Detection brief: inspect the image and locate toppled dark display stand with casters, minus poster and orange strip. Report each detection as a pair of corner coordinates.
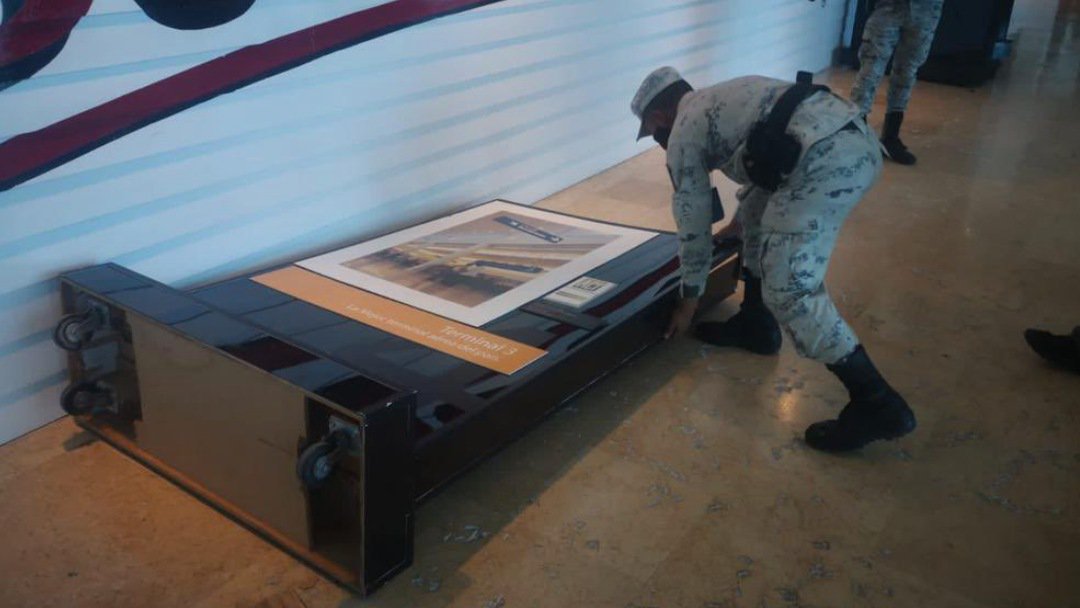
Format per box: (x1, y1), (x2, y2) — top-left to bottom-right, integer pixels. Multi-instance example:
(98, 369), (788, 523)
(56, 202), (739, 594)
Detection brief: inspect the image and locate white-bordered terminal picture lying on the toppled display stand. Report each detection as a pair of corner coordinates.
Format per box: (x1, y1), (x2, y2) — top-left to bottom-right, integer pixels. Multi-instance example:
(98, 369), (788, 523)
(297, 201), (656, 327)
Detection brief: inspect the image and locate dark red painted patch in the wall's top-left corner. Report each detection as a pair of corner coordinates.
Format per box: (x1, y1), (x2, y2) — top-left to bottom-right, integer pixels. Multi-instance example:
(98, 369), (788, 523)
(0, 0), (92, 62)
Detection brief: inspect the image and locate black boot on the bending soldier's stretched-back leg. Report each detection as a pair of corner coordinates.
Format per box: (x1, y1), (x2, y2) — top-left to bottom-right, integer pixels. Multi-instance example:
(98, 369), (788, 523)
(806, 344), (915, 451)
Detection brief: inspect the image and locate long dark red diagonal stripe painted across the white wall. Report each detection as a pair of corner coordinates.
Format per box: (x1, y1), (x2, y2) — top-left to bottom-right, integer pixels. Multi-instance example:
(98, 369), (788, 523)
(0, 0), (501, 191)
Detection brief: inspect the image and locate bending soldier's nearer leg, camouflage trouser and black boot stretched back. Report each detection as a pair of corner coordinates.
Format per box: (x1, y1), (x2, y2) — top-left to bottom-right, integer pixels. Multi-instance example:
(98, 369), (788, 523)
(761, 131), (915, 451)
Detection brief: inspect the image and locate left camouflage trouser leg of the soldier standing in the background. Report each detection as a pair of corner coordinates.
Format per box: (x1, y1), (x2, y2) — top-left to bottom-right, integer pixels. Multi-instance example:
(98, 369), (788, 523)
(851, 0), (907, 116)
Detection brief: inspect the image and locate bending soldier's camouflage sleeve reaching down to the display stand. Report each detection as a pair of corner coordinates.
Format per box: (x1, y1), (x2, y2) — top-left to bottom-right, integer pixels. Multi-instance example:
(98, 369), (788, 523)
(667, 141), (713, 298)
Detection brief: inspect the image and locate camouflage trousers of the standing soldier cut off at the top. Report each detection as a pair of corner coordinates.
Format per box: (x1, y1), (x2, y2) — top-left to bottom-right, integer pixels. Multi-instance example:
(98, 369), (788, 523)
(851, 0), (944, 116)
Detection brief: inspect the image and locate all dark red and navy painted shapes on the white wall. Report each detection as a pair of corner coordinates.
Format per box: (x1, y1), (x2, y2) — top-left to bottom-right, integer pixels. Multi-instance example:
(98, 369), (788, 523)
(0, 0), (502, 191)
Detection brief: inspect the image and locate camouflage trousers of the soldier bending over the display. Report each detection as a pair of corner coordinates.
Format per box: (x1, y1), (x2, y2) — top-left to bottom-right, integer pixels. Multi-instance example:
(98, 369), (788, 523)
(735, 124), (881, 364)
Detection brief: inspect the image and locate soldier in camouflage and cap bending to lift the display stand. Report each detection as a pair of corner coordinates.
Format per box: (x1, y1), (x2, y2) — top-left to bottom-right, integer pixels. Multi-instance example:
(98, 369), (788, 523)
(631, 67), (915, 450)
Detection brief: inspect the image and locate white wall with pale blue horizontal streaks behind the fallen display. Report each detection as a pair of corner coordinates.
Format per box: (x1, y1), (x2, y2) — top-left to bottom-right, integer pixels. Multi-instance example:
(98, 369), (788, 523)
(0, 0), (843, 442)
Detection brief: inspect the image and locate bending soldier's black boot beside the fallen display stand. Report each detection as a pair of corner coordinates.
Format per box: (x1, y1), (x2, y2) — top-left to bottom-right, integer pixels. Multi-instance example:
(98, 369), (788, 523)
(696, 272), (783, 354)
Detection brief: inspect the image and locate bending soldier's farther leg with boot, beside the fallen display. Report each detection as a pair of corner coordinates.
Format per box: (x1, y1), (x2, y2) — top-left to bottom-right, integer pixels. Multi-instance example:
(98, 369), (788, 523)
(696, 187), (783, 354)
